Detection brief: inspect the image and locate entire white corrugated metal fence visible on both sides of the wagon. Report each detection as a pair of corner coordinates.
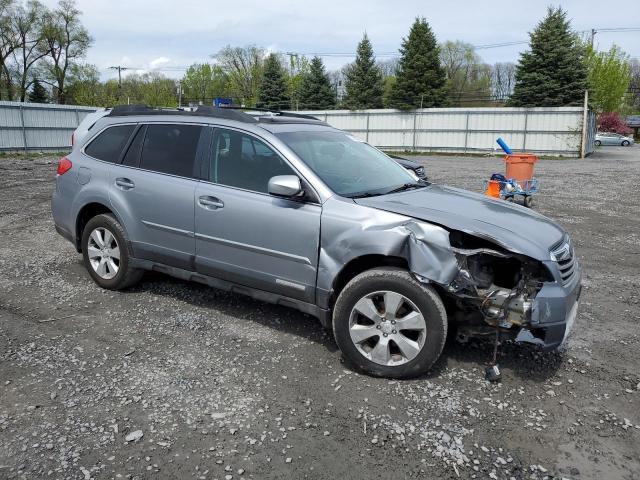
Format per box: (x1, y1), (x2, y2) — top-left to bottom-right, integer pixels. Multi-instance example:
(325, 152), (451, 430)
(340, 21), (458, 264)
(0, 102), (595, 156)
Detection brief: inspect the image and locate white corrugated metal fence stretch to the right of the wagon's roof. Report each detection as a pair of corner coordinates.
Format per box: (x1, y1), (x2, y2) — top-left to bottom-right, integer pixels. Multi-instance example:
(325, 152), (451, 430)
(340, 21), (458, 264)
(299, 107), (595, 156)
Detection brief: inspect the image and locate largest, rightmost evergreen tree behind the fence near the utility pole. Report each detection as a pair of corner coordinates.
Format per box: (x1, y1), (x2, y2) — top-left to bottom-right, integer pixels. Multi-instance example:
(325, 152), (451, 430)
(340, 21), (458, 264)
(508, 7), (587, 107)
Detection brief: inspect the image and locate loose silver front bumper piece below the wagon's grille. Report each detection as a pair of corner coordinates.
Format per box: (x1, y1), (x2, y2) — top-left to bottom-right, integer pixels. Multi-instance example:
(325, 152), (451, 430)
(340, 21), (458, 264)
(516, 260), (582, 350)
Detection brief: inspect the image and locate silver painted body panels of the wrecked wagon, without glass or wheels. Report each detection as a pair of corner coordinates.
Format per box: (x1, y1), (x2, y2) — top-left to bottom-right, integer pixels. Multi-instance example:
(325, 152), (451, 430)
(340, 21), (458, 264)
(52, 115), (580, 348)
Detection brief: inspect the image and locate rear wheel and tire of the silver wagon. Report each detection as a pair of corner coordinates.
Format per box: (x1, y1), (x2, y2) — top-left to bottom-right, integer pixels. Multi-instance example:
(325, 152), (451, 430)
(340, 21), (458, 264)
(82, 214), (143, 290)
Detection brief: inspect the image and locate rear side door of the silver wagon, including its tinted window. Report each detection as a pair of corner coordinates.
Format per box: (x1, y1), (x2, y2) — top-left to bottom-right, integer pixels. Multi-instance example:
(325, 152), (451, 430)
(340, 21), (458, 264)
(110, 123), (206, 270)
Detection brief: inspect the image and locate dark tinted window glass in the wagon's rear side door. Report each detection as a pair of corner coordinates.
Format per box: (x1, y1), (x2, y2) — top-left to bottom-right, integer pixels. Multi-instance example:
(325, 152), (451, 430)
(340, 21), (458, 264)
(140, 124), (203, 177)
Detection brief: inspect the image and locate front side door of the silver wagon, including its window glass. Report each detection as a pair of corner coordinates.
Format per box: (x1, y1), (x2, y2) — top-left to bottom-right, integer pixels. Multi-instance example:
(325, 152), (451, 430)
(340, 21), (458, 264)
(195, 129), (321, 302)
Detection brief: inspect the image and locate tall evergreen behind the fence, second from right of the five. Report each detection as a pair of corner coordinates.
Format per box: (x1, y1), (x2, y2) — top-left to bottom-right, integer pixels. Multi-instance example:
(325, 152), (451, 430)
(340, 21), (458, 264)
(389, 18), (447, 110)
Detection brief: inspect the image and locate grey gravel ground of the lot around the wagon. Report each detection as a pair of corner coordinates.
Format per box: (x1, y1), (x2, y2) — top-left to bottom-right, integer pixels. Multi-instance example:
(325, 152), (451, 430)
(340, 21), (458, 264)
(0, 147), (640, 480)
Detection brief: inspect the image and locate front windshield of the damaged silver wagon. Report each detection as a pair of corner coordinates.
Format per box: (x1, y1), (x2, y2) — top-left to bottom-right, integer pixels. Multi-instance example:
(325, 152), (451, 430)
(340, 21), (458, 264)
(276, 130), (419, 197)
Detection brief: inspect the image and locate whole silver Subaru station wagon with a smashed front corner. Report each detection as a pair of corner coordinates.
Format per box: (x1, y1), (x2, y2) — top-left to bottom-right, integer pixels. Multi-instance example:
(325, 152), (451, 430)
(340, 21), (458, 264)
(52, 106), (581, 378)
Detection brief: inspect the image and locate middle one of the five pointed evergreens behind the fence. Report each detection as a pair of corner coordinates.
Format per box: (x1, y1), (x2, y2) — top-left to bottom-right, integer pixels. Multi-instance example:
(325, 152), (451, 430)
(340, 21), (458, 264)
(343, 33), (384, 110)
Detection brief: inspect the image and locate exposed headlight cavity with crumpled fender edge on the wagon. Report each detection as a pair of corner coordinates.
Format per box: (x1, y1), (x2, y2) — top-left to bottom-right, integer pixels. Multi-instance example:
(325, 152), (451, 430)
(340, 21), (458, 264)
(404, 222), (554, 345)
